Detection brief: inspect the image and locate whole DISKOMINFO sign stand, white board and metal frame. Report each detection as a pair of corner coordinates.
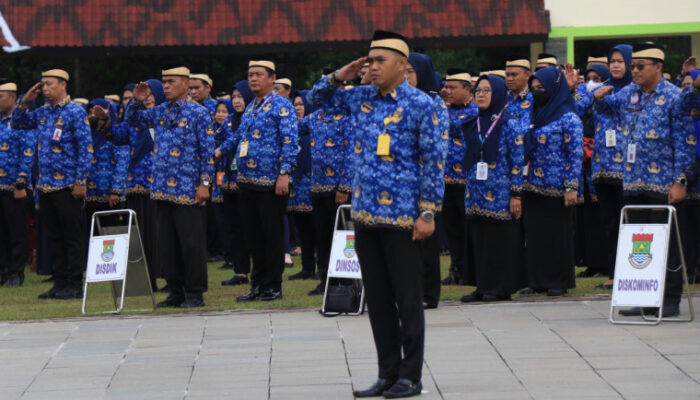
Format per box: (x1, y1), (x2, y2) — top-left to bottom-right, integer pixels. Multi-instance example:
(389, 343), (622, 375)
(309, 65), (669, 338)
(610, 205), (695, 325)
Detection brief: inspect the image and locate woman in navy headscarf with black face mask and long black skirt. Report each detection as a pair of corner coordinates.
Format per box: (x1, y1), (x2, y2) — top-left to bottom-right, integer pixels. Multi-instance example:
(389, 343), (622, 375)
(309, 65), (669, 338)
(523, 67), (583, 296)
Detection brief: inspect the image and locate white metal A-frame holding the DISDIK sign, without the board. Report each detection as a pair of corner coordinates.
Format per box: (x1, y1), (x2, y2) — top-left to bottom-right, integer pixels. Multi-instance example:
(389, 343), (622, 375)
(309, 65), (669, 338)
(82, 209), (156, 315)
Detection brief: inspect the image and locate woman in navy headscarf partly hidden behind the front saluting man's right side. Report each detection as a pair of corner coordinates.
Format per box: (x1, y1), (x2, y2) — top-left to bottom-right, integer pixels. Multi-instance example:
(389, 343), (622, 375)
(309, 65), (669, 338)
(406, 52), (449, 308)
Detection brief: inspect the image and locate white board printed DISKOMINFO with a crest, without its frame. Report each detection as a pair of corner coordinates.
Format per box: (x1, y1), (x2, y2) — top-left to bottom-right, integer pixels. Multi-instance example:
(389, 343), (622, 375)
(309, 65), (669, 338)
(612, 224), (669, 307)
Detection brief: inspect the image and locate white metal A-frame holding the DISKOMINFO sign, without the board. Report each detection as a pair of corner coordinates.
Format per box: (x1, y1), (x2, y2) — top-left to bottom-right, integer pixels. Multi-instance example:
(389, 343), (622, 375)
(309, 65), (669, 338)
(610, 205), (695, 325)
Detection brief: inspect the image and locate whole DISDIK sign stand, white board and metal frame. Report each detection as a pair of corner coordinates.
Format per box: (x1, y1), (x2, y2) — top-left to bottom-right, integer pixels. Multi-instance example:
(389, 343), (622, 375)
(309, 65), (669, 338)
(82, 209), (156, 314)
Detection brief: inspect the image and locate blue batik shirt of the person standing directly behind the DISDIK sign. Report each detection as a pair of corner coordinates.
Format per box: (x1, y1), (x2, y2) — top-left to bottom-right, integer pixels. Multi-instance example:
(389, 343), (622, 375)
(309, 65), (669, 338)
(85, 128), (129, 203)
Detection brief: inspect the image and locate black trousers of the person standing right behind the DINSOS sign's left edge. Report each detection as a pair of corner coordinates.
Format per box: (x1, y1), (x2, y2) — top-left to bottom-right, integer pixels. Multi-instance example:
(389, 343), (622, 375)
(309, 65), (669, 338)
(311, 193), (338, 284)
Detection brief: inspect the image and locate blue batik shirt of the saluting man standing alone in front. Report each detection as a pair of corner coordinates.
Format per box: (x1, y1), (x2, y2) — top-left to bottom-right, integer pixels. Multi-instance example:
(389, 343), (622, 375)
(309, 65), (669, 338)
(307, 77), (446, 229)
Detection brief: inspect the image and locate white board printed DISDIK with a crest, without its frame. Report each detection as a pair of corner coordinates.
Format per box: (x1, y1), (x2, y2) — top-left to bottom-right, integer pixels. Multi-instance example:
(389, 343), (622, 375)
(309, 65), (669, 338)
(85, 234), (129, 282)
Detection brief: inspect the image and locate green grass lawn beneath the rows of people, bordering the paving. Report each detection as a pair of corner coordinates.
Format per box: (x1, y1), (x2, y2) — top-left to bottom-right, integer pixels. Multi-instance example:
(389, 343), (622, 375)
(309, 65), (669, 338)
(0, 257), (700, 321)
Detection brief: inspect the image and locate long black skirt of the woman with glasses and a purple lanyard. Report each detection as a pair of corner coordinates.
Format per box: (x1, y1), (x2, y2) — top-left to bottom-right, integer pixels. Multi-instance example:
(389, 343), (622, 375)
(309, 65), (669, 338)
(466, 217), (525, 296)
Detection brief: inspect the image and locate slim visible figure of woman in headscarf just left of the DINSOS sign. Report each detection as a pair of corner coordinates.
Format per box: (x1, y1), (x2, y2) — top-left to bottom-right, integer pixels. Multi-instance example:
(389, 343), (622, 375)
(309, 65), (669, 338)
(287, 90), (318, 283)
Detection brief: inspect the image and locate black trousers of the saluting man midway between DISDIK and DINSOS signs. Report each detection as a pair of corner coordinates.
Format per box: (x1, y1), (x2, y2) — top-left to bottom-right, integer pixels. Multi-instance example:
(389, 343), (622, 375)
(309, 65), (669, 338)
(238, 189), (289, 291)
